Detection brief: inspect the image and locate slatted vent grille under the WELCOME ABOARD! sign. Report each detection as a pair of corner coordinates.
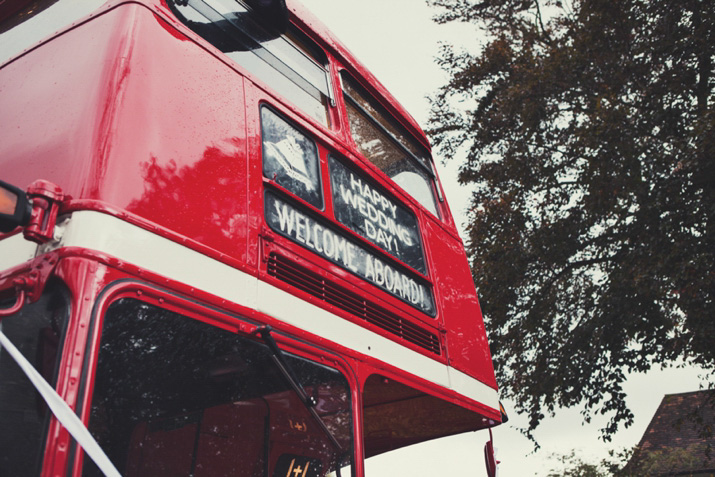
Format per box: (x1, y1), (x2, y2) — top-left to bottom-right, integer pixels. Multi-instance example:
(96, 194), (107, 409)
(268, 253), (441, 355)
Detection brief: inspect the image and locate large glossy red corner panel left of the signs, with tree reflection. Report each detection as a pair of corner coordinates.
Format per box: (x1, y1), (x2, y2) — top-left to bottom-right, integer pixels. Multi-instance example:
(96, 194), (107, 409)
(0, 3), (248, 261)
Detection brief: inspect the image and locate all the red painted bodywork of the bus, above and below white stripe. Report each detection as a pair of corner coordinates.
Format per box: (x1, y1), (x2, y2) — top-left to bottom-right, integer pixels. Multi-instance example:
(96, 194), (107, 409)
(0, 0), (501, 476)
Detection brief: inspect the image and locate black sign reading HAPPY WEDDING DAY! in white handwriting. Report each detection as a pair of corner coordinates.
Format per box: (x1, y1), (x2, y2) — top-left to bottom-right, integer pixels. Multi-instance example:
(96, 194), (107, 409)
(329, 156), (427, 275)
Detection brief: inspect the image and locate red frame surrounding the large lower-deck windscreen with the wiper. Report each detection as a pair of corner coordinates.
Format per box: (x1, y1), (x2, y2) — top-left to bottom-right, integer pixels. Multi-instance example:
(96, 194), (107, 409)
(75, 277), (362, 477)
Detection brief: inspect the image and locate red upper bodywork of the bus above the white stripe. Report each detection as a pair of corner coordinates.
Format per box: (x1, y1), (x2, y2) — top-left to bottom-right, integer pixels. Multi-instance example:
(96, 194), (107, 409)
(0, 3), (496, 387)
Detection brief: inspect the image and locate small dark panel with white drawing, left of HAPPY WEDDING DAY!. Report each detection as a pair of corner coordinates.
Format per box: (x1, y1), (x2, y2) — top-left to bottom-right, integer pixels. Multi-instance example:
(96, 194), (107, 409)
(261, 107), (323, 208)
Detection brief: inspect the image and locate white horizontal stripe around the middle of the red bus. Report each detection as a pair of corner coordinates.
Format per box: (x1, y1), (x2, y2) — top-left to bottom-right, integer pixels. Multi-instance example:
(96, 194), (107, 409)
(0, 211), (499, 410)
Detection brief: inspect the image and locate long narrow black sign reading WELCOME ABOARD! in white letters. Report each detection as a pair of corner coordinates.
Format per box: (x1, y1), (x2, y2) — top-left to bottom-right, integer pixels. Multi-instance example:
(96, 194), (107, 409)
(265, 191), (435, 316)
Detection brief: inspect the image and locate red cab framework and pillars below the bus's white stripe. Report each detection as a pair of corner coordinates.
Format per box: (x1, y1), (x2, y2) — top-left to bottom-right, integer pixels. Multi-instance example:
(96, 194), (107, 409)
(5, 248), (498, 476)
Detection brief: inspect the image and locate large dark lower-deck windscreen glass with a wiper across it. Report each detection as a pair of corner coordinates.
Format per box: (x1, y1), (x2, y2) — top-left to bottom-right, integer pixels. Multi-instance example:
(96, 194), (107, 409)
(84, 299), (352, 477)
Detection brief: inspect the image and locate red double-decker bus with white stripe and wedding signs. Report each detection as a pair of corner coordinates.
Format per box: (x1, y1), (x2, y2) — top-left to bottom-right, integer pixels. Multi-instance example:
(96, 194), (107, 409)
(0, 0), (505, 477)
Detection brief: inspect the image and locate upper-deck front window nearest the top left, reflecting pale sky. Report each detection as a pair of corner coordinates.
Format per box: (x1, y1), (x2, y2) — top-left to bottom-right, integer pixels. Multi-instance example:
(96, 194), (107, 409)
(170, 0), (332, 126)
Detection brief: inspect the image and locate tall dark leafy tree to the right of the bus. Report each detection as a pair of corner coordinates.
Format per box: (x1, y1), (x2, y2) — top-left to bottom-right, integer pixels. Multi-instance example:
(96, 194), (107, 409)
(429, 0), (715, 439)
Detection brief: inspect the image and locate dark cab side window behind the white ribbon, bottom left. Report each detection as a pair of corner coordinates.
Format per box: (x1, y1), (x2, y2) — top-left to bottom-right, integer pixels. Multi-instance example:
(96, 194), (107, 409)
(0, 285), (70, 477)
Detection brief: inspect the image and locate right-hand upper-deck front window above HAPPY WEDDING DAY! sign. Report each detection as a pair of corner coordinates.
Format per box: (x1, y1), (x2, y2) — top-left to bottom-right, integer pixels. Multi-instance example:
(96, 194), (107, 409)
(342, 73), (439, 216)
